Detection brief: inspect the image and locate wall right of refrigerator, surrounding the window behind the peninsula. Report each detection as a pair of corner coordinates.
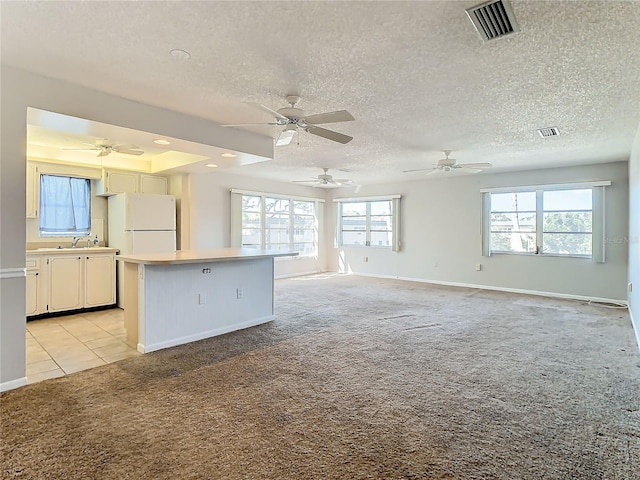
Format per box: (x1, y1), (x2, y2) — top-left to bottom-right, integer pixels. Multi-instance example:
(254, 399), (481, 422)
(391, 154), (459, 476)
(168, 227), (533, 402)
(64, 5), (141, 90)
(189, 172), (327, 277)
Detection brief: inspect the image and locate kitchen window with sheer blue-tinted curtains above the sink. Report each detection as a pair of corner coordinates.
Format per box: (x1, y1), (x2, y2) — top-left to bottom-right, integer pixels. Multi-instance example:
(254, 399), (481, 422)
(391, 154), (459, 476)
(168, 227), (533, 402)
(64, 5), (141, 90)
(40, 175), (91, 237)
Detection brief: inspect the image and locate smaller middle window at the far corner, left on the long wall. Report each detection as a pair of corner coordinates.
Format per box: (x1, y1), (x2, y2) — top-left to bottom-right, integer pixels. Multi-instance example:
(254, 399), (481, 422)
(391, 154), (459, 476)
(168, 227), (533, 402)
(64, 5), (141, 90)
(338, 197), (400, 250)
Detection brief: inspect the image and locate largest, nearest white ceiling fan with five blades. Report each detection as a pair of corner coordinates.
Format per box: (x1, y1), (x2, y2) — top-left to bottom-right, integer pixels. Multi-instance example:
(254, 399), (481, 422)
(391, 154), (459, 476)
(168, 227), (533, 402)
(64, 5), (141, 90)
(221, 95), (355, 146)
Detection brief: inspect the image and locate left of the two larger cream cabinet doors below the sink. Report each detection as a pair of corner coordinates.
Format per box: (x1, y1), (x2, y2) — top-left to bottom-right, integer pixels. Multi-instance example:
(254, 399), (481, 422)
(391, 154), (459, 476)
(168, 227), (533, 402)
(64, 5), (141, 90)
(49, 255), (83, 312)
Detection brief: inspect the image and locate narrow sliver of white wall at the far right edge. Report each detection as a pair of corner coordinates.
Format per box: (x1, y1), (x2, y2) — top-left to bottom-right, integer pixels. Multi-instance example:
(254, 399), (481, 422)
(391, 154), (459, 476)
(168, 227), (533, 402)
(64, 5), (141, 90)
(629, 124), (640, 347)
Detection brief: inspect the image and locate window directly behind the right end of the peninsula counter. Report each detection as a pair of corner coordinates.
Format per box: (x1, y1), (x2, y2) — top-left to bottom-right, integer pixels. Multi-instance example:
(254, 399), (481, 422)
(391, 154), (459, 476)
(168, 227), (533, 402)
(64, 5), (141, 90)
(241, 194), (318, 255)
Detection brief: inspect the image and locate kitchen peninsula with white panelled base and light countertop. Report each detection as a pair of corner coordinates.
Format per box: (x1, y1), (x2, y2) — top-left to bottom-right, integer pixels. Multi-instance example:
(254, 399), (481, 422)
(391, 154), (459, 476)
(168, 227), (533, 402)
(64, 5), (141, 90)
(117, 248), (297, 353)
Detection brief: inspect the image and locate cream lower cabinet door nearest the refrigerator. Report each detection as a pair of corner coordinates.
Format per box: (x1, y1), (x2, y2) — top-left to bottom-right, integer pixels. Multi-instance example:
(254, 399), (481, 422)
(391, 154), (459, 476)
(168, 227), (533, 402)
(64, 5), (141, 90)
(84, 255), (116, 307)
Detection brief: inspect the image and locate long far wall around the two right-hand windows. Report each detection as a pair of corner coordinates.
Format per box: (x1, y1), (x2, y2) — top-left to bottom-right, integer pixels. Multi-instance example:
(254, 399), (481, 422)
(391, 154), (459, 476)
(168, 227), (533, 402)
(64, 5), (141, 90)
(327, 162), (628, 300)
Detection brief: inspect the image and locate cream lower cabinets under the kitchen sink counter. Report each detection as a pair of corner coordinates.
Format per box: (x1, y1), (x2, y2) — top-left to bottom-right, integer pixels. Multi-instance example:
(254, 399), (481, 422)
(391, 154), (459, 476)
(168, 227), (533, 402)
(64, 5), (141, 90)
(26, 253), (116, 316)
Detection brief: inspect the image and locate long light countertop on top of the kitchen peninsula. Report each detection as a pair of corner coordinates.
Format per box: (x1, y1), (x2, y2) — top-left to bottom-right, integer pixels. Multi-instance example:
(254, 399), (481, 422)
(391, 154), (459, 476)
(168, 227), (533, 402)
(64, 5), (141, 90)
(116, 248), (298, 265)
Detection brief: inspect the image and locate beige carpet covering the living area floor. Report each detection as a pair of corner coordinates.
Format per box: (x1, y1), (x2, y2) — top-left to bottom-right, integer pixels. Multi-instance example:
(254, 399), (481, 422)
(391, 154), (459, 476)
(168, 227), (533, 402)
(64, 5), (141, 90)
(0, 276), (640, 480)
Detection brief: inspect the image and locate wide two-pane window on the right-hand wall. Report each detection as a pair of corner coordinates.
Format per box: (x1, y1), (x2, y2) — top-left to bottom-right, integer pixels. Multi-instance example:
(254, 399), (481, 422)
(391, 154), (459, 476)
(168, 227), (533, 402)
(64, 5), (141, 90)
(483, 182), (610, 261)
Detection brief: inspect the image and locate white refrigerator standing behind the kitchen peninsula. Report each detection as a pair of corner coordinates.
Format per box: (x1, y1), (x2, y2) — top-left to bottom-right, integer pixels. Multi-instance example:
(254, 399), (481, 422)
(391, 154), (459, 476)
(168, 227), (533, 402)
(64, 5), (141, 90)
(107, 193), (176, 308)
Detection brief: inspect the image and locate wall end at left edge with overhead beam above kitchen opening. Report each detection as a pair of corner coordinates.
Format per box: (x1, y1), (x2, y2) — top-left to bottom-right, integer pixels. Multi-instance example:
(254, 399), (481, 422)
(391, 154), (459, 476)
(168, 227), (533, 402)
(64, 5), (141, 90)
(0, 65), (273, 390)
